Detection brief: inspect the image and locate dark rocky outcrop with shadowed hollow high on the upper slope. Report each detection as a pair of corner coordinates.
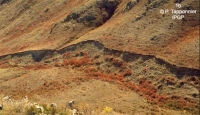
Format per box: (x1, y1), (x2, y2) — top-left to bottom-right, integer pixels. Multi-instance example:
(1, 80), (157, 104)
(64, 0), (119, 26)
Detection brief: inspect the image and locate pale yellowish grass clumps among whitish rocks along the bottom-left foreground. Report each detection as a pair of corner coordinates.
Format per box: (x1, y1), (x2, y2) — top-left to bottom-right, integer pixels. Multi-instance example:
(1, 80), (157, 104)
(0, 96), (123, 115)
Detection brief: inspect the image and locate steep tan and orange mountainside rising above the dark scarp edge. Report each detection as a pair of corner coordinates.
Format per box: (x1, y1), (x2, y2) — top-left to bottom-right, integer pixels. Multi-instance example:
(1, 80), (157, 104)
(0, 0), (199, 68)
